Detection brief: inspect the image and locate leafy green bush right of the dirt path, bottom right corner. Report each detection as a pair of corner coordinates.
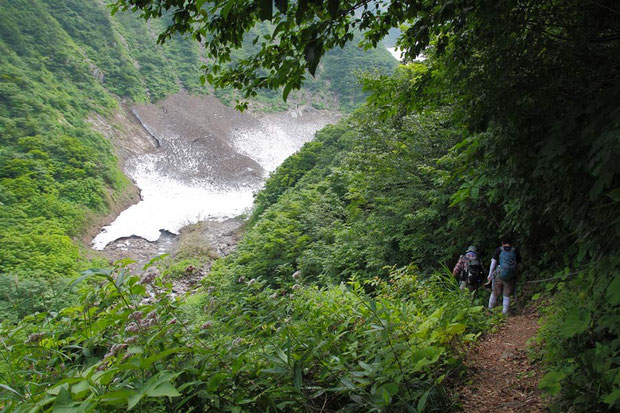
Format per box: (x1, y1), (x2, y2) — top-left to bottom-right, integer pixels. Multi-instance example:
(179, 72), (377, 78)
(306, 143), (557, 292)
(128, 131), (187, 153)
(539, 257), (620, 411)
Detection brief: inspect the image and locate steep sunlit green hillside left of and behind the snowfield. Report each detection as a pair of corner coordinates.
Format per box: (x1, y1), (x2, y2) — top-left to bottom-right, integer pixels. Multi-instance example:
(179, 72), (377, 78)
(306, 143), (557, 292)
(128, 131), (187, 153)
(0, 0), (395, 313)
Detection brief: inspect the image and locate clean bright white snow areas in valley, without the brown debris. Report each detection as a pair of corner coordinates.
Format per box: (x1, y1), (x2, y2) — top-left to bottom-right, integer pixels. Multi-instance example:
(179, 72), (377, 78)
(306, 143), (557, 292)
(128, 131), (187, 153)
(93, 109), (333, 250)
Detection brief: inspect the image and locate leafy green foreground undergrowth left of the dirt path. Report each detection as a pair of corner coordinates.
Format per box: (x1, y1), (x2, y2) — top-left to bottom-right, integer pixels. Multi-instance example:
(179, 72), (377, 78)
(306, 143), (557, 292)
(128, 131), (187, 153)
(0, 260), (488, 412)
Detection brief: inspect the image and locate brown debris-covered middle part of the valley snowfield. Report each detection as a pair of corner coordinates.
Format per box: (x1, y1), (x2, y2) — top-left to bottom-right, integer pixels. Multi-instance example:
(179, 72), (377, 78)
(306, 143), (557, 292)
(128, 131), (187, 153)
(133, 93), (264, 187)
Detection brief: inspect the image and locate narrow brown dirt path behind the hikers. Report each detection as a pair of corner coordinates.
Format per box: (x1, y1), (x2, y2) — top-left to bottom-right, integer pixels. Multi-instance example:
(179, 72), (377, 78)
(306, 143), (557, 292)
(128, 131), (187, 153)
(458, 310), (546, 412)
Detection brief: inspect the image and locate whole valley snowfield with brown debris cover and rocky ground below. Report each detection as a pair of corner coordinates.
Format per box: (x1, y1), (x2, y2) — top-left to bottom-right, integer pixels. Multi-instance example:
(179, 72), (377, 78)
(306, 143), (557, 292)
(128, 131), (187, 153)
(91, 93), (339, 280)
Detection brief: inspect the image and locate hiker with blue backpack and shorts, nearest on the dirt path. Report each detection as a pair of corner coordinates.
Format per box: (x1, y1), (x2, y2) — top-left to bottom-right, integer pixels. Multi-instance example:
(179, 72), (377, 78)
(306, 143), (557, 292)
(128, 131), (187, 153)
(487, 235), (521, 315)
